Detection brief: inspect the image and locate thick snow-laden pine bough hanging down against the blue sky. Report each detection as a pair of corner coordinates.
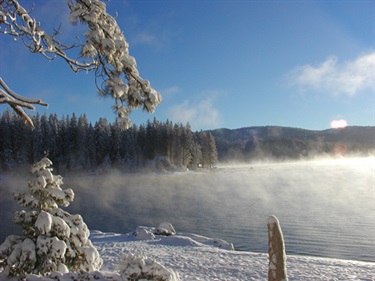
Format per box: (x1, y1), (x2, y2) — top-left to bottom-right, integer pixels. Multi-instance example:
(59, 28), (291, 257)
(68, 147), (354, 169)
(68, 0), (161, 127)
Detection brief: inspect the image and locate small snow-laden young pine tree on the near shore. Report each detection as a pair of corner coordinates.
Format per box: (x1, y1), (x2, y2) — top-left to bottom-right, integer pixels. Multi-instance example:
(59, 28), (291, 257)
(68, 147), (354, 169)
(0, 158), (103, 276)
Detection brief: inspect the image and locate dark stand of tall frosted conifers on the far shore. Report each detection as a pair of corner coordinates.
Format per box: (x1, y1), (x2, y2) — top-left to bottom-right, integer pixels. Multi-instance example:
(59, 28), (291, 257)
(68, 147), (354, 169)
(0, 110), (218, 173)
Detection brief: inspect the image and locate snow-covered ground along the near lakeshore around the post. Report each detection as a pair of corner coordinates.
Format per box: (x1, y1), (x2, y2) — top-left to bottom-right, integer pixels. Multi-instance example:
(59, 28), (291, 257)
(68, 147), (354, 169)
(0, 226), (375, 281)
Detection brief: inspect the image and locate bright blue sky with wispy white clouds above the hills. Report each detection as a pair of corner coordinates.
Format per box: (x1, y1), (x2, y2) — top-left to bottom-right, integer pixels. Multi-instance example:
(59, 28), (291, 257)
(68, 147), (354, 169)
(0, 0), (375, 130)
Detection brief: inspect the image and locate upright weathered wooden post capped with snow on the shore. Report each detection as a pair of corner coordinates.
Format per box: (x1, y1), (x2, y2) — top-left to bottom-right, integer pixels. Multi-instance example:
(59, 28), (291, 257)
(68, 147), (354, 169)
(267, 216), (288, 281)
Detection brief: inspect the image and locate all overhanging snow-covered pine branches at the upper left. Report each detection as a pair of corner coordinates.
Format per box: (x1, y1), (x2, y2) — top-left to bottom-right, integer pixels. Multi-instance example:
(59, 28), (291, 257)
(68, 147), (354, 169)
(0, 0), (161, 128)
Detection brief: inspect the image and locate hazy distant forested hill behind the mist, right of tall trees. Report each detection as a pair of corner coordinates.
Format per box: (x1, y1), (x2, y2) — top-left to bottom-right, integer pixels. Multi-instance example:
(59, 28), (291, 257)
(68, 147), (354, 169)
(210, 126), (375, 161)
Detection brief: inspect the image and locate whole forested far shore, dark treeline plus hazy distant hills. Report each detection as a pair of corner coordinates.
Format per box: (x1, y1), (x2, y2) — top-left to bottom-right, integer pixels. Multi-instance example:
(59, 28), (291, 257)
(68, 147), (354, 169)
(0, 110), (375, 173)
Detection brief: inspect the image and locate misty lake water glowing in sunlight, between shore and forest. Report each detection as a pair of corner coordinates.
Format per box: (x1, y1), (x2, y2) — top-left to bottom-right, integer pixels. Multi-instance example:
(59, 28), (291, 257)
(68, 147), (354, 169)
(0, 158), (375, 262)
